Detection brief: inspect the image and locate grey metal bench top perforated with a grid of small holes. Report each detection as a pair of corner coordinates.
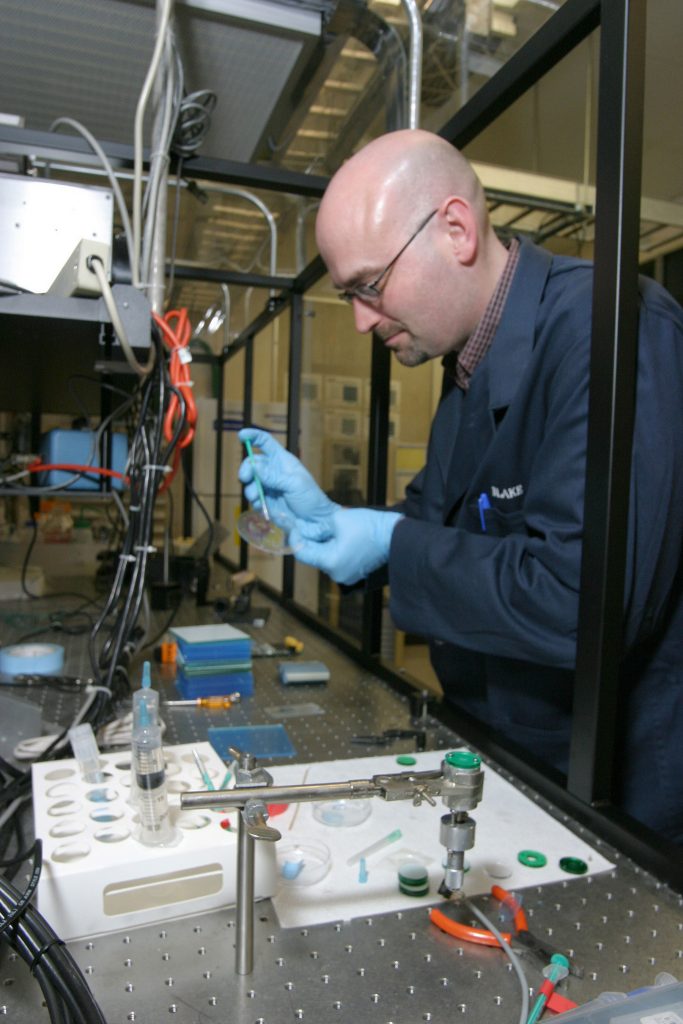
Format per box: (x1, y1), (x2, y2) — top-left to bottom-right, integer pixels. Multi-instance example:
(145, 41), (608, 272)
(0, 577), (683, 1024)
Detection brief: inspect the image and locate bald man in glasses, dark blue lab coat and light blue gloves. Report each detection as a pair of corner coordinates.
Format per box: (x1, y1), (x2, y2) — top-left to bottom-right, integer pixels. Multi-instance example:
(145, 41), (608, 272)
(240, 131), (683, 842)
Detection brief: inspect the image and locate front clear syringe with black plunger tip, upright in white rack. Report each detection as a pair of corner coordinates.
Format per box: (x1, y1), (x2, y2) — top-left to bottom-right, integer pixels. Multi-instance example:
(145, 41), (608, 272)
(133, 722), (179, 846)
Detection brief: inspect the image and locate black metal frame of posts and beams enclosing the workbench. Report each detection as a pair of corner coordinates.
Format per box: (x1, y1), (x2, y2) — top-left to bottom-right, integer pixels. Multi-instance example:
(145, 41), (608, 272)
(0, 0), (671, 888)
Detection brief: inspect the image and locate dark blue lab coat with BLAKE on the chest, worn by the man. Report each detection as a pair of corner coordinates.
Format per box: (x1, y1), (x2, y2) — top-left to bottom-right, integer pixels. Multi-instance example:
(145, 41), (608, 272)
(389, 242), (683, 842)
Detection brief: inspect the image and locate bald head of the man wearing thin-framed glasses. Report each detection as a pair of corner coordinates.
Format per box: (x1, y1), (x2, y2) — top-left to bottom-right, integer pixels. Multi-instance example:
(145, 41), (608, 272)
(315, 130), (507, 367)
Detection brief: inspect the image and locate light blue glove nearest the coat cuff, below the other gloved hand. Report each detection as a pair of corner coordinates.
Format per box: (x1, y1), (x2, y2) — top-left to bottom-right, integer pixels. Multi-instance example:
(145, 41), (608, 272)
(290, 507), (403, 585)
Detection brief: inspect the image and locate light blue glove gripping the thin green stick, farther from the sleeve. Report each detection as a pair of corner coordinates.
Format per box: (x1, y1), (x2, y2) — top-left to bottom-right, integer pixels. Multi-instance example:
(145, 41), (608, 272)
(238, 427), (339, 537)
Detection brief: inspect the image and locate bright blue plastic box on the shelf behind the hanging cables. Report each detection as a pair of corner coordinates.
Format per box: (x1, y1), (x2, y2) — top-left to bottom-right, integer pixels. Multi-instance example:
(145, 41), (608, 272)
(38, 429), (128, 490)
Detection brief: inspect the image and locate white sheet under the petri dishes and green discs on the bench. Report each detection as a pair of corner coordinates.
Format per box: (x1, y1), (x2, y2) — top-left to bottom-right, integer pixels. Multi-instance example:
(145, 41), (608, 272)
(268, 751), (613, 928)
